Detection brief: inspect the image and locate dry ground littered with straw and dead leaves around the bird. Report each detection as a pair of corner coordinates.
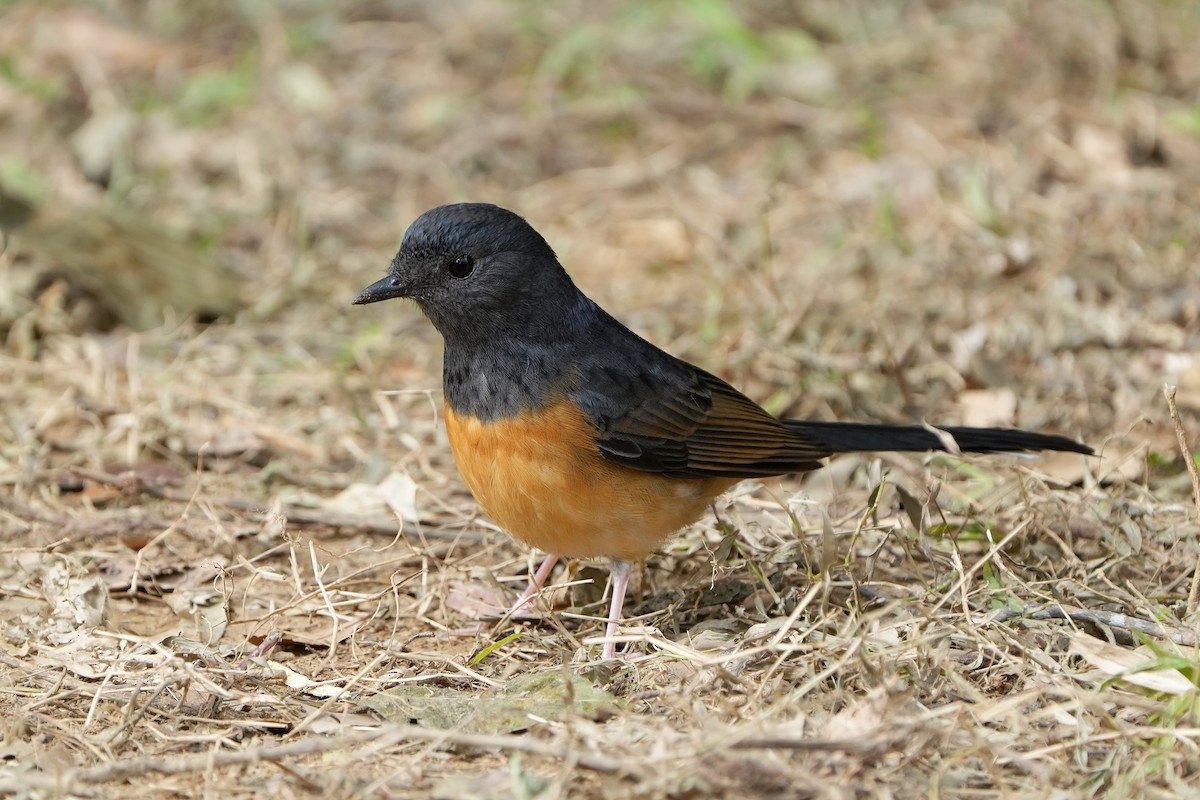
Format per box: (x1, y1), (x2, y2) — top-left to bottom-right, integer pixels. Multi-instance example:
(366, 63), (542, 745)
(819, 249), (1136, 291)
(0, 0), (1200, 800)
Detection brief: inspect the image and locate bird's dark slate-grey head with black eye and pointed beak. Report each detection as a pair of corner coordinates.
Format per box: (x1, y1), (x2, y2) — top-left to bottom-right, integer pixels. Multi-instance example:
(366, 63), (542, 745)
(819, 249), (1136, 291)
(354, 203), (587, 342)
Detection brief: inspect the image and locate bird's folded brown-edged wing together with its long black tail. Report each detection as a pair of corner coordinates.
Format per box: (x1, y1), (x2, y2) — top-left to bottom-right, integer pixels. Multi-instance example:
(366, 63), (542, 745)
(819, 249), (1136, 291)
(568, 307), (1092, 479)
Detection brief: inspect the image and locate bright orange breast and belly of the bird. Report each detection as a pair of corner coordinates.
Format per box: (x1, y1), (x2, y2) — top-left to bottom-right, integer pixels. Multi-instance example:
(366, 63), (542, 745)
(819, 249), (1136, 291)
(445, 402), (737, 560)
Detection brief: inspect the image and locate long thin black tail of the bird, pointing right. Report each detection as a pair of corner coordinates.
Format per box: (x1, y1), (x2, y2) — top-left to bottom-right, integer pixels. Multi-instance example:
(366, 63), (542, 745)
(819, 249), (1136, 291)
(782, 420), (1096, 456)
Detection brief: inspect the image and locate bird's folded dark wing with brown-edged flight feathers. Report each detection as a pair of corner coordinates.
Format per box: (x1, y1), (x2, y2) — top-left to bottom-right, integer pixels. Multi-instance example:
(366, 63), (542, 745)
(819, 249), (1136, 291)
(572, 359), (829, 479)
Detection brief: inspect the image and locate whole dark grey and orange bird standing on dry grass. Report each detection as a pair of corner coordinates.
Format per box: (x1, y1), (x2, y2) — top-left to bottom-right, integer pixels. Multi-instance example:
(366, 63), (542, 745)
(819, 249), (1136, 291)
(354, 203), (1093, 660)
